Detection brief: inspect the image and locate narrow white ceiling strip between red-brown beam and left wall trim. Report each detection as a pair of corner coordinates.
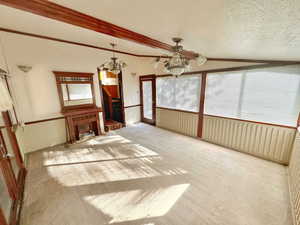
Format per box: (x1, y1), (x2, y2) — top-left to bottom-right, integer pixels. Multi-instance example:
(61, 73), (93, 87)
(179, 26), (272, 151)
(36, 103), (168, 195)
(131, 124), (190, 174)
(0, 5), (163, 55)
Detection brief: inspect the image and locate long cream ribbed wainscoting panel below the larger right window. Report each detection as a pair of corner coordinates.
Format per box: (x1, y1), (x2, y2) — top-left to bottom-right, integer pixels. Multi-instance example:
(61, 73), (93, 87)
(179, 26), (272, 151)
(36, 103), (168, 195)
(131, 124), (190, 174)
(203, 115), (296, 165)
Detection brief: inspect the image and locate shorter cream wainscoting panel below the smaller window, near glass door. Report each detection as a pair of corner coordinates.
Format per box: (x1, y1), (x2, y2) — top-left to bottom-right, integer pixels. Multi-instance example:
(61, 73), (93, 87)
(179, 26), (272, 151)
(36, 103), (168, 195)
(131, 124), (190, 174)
(156, 108), (198, 137)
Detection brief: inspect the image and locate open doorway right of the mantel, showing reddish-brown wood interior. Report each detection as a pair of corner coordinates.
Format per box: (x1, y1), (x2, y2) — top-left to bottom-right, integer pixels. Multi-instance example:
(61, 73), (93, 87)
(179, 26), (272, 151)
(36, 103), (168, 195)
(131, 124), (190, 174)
(98, 69), (126, 132)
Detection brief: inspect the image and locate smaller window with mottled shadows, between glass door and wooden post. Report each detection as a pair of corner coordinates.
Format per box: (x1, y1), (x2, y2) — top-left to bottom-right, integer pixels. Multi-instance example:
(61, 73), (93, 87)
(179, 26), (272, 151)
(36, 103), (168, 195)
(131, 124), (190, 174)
(156, 75), (201, 112)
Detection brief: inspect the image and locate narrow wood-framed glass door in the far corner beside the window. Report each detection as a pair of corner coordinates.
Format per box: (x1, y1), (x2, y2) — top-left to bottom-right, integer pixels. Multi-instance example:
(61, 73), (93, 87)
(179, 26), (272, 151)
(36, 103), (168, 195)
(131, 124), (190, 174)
(140, 75), (156, 125)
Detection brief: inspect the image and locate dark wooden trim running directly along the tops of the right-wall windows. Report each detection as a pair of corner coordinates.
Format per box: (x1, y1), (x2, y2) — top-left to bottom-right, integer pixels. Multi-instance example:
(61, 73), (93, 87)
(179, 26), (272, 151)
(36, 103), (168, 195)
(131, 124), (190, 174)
(156, 62), (300, 77)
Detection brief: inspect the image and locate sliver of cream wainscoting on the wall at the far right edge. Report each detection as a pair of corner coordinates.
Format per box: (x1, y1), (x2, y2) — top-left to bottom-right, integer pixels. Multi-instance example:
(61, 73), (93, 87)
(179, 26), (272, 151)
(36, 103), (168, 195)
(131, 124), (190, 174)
(288, 131), (300, 225)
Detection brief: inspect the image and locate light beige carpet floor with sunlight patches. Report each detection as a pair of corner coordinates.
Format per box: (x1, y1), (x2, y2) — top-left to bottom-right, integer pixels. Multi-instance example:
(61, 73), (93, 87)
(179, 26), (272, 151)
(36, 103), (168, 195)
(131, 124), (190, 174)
(21, 124), (292, 225)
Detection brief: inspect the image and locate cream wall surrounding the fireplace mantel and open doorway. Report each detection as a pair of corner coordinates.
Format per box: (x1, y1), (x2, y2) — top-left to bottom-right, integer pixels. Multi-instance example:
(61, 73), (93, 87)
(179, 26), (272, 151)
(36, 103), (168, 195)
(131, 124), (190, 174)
(0, 32), (148, 152)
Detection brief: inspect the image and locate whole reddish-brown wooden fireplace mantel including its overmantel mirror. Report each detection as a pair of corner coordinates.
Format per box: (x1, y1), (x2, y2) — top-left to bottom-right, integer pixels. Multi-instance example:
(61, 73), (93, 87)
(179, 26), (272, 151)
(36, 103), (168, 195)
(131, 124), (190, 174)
(53, 71), (102, 143)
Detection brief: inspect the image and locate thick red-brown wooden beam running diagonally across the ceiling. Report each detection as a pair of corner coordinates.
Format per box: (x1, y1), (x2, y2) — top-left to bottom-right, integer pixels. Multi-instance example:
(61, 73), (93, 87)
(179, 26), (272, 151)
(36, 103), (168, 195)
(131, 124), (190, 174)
(0, 0), (198, 58)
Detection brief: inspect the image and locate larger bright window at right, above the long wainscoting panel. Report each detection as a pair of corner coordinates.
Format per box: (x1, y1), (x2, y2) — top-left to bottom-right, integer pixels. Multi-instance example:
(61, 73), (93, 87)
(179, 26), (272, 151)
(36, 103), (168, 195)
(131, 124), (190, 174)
(204, 65), (300, 126)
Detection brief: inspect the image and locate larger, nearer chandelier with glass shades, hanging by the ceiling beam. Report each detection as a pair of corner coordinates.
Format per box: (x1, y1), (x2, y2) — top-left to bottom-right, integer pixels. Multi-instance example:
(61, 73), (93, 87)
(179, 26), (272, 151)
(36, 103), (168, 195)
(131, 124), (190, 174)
(156, 38), (207, 77)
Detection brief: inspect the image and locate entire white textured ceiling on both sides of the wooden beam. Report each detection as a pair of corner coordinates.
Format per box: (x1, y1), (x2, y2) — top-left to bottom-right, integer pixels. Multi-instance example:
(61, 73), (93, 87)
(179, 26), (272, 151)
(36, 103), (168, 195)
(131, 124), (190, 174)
(0, 0), (300, 60)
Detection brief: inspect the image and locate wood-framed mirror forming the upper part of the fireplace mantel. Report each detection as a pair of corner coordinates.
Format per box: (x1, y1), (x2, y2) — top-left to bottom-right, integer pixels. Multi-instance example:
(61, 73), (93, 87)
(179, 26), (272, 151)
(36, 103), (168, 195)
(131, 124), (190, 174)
(53, 71), (95, 112)
